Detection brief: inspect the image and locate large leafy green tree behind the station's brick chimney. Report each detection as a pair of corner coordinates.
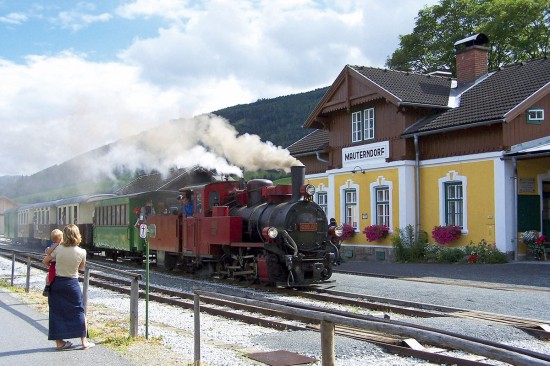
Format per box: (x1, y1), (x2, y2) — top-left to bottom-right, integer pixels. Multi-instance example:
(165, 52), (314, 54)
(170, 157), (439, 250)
(386, 0), (550, 74)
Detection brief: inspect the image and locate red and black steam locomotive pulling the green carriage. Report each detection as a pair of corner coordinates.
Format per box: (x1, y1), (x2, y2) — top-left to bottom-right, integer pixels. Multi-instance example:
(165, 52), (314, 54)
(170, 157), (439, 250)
(149, 166), (342, 287)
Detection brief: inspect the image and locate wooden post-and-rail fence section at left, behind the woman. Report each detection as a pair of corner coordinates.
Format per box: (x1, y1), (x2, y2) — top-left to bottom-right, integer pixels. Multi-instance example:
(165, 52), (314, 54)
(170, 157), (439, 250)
(0, 248), (141, 338)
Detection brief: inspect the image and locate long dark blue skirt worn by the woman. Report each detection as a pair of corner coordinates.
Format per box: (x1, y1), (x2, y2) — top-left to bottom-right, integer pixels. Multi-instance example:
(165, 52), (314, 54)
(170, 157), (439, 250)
(48, 276), (86, 340)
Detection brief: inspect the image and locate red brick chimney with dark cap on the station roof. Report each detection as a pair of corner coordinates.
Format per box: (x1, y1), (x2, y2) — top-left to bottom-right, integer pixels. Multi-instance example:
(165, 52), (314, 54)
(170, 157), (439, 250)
(454, 33), (490, 85)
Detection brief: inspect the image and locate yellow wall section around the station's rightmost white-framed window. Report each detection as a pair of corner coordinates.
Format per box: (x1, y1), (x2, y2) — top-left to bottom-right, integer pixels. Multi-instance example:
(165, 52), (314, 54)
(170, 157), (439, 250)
(420, 160), (495, 246)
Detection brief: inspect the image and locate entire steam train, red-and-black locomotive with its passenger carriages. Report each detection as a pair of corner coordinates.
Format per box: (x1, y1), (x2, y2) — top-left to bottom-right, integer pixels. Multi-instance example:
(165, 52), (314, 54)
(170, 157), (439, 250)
(4, 166), (342, 287)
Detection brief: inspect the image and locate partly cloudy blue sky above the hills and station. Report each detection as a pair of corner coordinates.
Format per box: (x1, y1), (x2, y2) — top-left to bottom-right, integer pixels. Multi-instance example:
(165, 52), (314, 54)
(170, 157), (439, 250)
(0, 0), (437, 176)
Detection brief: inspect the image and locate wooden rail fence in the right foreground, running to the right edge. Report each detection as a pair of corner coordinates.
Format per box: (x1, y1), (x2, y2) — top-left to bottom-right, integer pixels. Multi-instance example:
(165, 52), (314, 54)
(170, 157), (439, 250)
(193, 288), (548, 366)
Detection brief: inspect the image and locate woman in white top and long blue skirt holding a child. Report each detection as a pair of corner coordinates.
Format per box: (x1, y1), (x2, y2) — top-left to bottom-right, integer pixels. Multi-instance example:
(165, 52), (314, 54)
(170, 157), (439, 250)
(43, 224), (95, 350)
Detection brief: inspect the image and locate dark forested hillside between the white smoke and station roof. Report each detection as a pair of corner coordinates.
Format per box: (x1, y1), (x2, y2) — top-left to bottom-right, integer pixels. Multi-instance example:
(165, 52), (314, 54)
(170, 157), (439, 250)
(212, 87), (328, 147)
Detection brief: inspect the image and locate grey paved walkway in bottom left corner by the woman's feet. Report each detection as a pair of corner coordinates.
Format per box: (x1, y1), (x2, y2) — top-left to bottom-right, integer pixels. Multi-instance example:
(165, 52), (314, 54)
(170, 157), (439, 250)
(0, 288), (132, 366)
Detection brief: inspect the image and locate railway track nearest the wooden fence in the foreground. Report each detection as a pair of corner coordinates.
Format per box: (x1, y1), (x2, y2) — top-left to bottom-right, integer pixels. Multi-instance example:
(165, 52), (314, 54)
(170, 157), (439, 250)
(86, 273), (550, 366)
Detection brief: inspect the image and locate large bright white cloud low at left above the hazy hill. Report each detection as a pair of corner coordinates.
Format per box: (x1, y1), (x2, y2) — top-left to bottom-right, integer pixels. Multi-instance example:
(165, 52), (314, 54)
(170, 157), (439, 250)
(0, 54), (182, 174)
